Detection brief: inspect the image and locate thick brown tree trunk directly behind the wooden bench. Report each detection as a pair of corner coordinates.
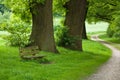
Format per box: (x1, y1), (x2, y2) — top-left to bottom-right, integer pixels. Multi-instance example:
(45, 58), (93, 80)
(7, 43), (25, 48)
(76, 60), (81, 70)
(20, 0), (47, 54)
(30, 0), (57, 53)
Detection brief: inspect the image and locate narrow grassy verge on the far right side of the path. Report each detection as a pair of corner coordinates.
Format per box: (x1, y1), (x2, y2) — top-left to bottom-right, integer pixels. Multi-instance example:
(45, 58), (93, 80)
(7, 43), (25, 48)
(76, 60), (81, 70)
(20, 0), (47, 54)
(100, 34), (120, 50)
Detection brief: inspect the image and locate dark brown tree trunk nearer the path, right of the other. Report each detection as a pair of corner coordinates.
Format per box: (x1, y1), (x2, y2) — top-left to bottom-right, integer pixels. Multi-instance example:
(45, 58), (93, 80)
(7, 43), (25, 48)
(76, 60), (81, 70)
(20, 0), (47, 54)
(65, 0), (87, 51)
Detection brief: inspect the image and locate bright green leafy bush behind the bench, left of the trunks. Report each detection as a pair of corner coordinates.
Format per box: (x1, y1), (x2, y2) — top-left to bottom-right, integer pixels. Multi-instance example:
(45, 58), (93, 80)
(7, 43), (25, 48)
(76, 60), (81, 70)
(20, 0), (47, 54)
(4, 15), (30, 46)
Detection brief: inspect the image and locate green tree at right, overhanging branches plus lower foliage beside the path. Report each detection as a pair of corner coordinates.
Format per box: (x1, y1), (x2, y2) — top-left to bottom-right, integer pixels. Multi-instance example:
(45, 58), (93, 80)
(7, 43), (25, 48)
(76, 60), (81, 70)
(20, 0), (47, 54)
(87, 0), (120, 38)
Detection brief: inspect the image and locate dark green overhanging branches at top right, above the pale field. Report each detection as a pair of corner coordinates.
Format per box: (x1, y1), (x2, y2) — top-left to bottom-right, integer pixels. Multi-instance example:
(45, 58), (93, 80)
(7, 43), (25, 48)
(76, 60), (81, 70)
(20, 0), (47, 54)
(87, 0), (120, 23)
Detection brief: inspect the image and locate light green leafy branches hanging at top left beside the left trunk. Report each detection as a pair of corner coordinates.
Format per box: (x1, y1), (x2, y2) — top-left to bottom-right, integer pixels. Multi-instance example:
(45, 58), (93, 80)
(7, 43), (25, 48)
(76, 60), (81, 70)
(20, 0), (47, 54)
(4, 0), (45, 22)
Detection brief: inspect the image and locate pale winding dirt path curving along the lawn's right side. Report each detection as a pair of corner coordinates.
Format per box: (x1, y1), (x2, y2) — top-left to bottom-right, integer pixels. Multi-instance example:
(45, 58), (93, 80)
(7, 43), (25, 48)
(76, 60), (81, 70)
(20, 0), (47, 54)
(87, 35), (120, 80)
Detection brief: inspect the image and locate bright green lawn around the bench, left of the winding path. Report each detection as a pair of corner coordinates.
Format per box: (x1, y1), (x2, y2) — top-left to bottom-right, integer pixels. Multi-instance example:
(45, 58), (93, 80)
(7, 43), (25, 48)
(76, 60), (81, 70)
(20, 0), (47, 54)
(0, 40), (111, 80)
